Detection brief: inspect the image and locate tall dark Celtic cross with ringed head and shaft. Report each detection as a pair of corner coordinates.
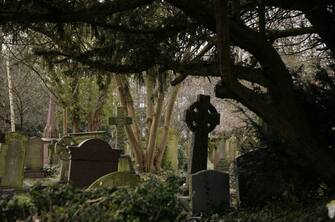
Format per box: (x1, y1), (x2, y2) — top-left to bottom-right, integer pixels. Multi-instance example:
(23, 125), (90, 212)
(185, 94), (220, 174)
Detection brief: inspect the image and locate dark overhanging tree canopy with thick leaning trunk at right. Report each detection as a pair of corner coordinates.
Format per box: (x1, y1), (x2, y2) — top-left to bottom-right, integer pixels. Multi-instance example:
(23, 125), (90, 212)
(0, 0), (335, 184)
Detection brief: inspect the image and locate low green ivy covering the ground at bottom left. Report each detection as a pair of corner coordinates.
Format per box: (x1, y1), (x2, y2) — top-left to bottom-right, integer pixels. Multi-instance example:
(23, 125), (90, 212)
(0, 176), (183, 222)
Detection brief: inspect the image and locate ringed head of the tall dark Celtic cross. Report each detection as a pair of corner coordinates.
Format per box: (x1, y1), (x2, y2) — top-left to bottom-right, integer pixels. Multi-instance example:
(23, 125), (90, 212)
(185, 95), (220, 133)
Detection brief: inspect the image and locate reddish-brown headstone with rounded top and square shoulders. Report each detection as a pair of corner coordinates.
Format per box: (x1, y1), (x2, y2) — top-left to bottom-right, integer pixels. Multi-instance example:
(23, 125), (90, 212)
(68, 139), (122, 187)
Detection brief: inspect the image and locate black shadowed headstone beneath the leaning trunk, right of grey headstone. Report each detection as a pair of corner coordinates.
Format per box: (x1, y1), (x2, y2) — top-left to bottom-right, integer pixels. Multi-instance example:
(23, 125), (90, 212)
(237, 149), (286, 207)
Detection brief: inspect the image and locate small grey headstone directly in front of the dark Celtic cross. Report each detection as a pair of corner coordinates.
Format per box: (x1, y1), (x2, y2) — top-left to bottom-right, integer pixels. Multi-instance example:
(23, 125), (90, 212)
(191, 170), (230, 215)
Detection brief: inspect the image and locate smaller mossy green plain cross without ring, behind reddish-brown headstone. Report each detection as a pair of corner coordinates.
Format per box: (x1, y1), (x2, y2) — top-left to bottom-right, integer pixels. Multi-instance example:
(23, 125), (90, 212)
(109, 106), (132, 152)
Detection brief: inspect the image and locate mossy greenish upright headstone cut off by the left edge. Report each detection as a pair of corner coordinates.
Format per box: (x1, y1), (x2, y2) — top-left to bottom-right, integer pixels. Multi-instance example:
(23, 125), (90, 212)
(0, 132), (28, 189)
